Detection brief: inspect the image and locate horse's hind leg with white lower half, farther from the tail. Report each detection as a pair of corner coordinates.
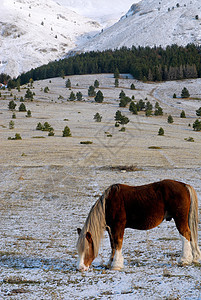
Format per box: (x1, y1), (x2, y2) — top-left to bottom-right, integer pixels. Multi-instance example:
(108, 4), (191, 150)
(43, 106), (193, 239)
(175, 217), (193, 265)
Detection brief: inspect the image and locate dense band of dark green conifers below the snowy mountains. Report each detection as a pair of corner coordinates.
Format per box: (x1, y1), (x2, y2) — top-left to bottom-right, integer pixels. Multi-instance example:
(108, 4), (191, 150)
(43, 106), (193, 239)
(5, 44), (201, 88)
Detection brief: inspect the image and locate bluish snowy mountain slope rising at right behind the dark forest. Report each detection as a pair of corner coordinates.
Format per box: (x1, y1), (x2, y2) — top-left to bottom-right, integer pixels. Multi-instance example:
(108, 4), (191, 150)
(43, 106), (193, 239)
(77, 0), (201, 51)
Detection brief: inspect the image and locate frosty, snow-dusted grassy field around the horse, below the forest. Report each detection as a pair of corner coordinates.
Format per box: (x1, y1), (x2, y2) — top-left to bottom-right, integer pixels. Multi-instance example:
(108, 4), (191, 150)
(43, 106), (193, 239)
(0, 74), (201, 299)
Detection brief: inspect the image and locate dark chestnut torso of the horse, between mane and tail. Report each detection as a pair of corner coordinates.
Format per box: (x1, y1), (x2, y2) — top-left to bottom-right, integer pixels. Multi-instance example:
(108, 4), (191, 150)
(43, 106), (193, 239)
(107, 179), (190, 230)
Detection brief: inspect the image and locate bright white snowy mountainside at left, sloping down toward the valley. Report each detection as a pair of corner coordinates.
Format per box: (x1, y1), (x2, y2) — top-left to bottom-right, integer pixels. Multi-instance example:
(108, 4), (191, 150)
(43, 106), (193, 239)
(0, 0), (101, 77)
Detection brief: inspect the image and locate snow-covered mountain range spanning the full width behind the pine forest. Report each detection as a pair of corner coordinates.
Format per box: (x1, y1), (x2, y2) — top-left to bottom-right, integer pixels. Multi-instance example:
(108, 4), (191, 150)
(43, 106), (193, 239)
(0, 0), (201, 77)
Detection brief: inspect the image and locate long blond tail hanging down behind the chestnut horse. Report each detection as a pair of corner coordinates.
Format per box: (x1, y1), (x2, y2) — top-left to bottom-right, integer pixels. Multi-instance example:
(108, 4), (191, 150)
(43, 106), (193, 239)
(186, 185), (201, 262)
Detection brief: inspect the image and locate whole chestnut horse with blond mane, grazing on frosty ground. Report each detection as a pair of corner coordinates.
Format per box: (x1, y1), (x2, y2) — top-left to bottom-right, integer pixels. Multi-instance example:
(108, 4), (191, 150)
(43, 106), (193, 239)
(77, 179), (201, 271)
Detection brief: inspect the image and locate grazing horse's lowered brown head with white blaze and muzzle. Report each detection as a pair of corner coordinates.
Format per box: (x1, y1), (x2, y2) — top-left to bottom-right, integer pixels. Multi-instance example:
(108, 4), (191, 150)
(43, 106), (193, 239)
(77, 228), (95, 271)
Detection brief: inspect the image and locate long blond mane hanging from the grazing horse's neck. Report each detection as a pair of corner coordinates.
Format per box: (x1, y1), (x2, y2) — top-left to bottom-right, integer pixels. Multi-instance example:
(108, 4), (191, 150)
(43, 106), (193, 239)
(77, 187), (111, 257)
